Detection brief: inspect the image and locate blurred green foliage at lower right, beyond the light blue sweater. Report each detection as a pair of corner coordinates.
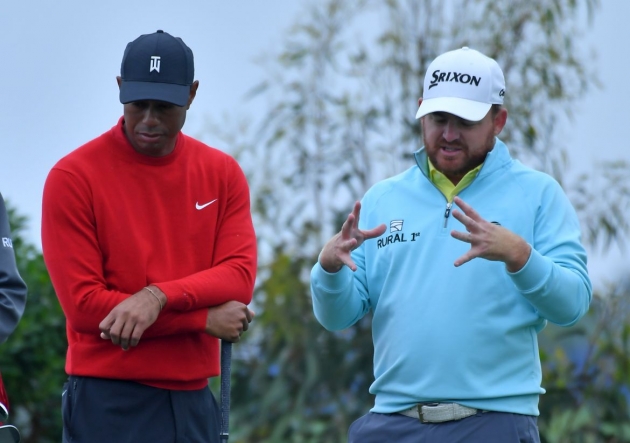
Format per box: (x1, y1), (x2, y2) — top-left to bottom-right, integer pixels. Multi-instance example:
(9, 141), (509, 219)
(540, 280), (630, 443)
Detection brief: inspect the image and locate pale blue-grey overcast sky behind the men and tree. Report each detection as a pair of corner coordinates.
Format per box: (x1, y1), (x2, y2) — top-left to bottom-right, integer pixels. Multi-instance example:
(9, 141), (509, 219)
(0, 0), (630, 290)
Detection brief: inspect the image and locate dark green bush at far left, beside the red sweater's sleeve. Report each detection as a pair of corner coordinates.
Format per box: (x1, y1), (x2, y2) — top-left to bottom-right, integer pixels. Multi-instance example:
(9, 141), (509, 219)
(0, 205), (67, 443)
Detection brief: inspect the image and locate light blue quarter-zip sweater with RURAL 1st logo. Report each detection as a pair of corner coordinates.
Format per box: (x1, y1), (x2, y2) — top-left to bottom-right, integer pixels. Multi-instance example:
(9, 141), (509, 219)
(311, 139), (592, 415)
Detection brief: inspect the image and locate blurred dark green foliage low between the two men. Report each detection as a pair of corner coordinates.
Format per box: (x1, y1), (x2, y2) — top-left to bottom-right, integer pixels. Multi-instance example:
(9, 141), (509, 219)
(232, 251), (372, 442)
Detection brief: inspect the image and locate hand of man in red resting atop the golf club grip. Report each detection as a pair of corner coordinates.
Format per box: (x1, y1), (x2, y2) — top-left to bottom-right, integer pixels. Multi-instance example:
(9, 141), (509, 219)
(206, 300), (255, 342)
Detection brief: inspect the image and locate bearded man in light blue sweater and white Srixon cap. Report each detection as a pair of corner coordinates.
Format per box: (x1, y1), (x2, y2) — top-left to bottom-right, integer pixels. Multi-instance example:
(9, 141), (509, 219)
(311, 47), (592, 443)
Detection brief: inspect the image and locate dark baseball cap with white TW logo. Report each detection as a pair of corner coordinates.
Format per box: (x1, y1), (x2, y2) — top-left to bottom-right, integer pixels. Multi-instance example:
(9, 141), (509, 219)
(120, 30), (195, 106)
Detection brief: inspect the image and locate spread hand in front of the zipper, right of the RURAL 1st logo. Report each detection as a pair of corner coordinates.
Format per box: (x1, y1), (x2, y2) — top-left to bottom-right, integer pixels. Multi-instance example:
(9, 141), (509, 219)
(451, 197), (531, 272)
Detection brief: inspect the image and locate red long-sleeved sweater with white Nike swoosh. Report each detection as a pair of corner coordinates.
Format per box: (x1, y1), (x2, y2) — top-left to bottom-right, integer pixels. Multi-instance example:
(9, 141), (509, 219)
(42, 118), (256, 389)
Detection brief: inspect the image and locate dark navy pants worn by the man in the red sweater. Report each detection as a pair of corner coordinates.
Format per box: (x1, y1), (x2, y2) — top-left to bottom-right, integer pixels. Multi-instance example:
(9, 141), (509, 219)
(61, 376), (220, 443)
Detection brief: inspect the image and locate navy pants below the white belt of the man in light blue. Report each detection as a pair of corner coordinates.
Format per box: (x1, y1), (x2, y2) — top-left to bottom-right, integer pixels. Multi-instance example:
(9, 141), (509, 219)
(348, 412), (540, 443)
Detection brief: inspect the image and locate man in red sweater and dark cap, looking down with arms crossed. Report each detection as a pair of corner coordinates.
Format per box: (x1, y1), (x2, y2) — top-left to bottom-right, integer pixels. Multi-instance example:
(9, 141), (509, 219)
(42, 31), (256, 443)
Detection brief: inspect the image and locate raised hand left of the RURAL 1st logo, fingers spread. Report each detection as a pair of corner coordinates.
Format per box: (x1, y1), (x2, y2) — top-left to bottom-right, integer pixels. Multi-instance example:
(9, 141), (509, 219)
(319, 202), (387, 273)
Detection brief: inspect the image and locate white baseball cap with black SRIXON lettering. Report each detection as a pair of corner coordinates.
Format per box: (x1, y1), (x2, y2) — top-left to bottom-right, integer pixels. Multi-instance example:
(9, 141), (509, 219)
(416, 46), (505, 122)
